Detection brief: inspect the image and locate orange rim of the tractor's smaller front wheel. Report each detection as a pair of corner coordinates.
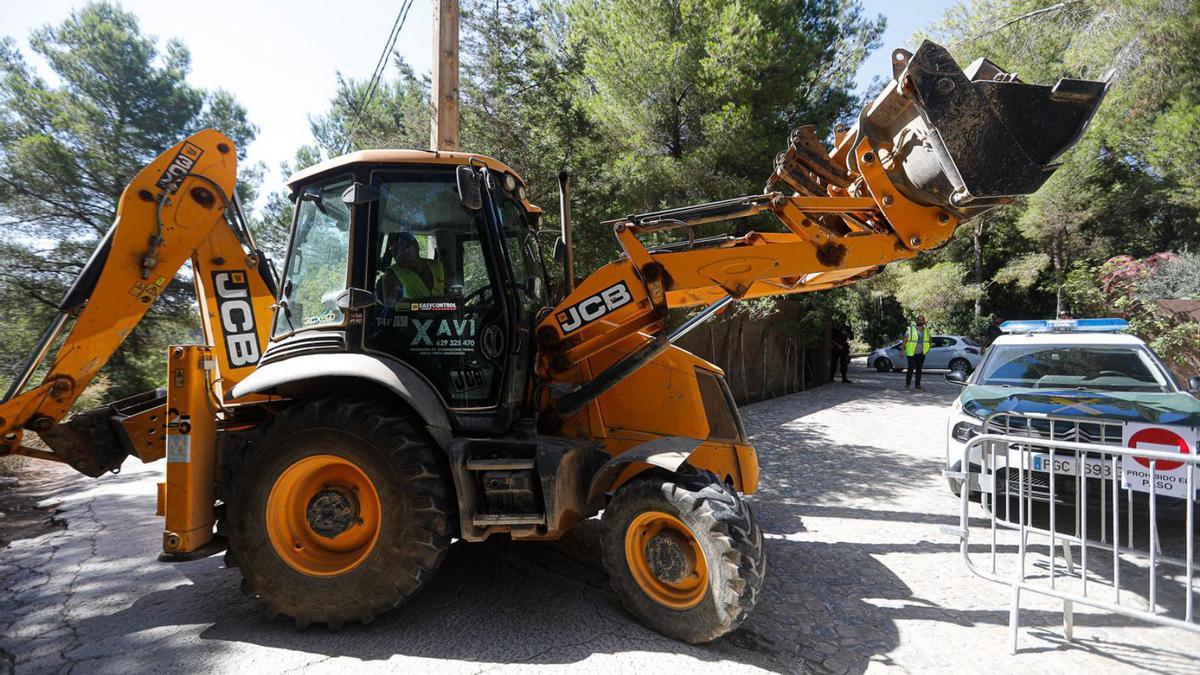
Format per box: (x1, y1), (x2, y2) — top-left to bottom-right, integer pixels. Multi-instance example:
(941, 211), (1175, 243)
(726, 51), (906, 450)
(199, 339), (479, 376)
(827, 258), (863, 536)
(625, 510), (708, 610)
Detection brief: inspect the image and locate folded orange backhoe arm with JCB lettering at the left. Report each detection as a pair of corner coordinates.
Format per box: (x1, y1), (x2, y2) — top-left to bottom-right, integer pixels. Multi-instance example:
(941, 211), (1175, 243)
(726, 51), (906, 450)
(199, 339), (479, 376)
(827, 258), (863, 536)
(0, 130), (275, 476)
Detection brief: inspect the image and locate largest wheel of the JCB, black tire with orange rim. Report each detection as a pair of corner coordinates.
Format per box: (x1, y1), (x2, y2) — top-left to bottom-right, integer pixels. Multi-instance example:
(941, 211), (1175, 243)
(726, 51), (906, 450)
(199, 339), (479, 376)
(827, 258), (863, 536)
(227, 399), (455, 631)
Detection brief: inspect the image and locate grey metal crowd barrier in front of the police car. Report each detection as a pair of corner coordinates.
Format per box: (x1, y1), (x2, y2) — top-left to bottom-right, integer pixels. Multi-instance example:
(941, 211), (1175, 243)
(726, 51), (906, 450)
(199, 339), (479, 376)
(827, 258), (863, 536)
(946, 413), (1200, 653)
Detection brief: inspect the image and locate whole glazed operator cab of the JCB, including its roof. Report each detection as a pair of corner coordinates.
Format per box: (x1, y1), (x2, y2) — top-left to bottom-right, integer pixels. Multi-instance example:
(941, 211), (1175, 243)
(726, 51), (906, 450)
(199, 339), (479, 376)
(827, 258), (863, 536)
(263, 150), (548, 430)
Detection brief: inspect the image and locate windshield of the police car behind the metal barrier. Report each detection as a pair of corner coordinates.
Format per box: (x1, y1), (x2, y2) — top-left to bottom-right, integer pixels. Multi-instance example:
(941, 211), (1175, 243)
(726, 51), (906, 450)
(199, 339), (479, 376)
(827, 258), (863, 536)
(978, 345), (1174, 393)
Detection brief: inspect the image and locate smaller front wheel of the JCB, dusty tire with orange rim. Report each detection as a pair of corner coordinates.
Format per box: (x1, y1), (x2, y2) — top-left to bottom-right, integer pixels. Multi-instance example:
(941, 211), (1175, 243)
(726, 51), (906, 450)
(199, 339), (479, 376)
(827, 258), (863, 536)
(601, 470), (767, 644)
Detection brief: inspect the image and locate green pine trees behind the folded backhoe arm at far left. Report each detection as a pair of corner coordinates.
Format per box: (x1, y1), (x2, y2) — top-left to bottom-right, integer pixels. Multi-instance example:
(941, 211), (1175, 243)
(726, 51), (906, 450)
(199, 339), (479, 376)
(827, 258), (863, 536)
(0, 2), (259, 396)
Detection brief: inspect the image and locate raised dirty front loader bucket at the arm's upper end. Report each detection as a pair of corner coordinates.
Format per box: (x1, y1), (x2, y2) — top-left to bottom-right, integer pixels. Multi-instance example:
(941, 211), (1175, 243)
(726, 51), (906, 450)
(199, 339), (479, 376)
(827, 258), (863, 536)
(859, 41), (1109, 216)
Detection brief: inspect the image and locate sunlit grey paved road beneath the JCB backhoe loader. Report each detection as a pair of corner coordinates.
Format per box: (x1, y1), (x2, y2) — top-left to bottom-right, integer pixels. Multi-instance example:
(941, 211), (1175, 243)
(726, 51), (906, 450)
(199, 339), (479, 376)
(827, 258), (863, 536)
(0, 366), (1200, 675)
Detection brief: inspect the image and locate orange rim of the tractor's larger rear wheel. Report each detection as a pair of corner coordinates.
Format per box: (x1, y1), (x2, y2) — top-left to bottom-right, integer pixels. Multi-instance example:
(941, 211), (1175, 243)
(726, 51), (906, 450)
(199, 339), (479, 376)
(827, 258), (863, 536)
(266, 455), (380, 577)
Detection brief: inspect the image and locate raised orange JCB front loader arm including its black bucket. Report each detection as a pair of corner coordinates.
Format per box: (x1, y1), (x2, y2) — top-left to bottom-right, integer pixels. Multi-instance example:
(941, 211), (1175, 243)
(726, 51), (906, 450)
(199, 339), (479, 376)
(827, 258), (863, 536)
(536, 41), (1108, 417)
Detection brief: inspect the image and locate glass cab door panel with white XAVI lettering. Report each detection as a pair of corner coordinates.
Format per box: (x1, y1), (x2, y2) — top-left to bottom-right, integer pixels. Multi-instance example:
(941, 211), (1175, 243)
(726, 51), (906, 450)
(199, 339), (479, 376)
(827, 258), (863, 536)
(364, 167), (505, 411)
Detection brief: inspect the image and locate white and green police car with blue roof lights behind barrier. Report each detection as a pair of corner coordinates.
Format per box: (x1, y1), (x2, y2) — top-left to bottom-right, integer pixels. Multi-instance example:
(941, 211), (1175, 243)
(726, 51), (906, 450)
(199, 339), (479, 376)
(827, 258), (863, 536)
(946, 318), (1200, 503)
